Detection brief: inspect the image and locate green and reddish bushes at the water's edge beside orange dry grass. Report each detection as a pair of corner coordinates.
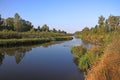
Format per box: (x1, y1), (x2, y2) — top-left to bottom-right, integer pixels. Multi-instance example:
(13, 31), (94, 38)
(71, 45), (102, 71)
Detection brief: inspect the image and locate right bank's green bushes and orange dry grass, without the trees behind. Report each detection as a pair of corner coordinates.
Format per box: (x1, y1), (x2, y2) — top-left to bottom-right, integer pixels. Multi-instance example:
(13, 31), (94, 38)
(71, 32), (120, 80)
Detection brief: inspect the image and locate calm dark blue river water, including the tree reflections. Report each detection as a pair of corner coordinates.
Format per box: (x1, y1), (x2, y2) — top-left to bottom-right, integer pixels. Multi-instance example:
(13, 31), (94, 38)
(0, 38), (90, 80)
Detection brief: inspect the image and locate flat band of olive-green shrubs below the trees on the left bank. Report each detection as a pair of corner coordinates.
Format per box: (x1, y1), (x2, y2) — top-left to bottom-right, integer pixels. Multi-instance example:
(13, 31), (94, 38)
(0, 30), (69, 39)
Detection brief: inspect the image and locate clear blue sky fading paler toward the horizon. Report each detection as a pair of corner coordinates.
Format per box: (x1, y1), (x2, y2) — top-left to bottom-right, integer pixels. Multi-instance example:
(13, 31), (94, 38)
(0, 0), (120, 33)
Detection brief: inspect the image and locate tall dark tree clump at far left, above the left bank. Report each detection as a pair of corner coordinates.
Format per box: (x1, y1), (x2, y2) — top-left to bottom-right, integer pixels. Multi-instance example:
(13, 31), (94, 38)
(0, 13), (33, 32)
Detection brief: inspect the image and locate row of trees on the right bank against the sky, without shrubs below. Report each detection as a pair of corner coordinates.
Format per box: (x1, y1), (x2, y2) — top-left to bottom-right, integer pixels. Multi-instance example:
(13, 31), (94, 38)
(75, 15), (120, 35)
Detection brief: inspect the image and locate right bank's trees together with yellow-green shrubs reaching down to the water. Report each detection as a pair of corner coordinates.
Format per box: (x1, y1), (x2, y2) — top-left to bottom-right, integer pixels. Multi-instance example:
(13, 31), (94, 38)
(75, 15), (120, 42)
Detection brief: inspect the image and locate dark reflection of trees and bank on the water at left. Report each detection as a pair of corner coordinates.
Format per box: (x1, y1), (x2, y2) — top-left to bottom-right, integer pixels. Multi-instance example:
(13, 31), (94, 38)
(0, 41), (63, 65)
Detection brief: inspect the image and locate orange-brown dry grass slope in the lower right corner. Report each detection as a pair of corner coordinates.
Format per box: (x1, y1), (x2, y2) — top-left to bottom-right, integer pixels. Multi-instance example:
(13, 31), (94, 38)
(85, 38), (120, 80)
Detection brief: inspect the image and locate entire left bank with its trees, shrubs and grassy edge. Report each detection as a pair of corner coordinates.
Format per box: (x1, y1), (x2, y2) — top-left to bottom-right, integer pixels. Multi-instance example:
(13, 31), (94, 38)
(0, 13), (72, 47)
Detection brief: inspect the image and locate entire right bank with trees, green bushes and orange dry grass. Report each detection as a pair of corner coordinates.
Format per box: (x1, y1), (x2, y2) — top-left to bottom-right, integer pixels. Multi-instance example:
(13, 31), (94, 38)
(74, 16), (120, 80)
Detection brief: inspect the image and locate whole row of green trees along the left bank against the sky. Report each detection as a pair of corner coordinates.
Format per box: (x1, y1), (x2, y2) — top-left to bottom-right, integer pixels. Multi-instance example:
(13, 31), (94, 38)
(0, 13), (66, 34)
